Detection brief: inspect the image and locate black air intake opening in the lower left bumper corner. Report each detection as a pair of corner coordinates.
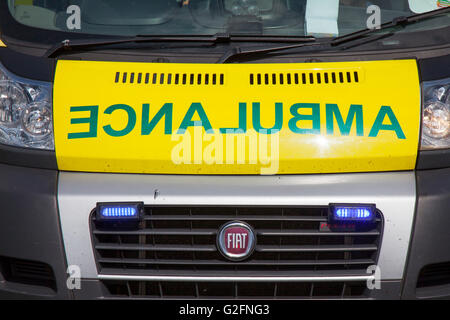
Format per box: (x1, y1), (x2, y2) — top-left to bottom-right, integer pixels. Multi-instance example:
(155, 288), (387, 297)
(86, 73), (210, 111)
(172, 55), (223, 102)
(0, 257), (56, 291)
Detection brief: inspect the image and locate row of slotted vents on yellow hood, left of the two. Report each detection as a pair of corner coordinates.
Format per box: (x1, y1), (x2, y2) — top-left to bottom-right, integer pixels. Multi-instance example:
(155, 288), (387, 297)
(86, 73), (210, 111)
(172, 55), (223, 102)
(114, 72), (225, 86)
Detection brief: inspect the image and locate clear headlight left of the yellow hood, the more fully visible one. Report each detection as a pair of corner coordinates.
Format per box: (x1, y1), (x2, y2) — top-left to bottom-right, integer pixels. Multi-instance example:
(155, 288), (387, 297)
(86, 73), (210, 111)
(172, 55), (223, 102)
(0, 64), (54, 150)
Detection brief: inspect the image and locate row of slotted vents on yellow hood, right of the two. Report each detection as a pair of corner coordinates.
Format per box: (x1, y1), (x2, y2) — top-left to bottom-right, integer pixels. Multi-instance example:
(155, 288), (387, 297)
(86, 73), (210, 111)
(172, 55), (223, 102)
(250, 70), (361, 85)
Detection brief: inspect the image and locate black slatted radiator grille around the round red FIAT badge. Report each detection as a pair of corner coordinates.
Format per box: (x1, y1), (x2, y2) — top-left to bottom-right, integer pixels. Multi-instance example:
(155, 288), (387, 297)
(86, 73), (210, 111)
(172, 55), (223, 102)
(91, 206), (382, 276)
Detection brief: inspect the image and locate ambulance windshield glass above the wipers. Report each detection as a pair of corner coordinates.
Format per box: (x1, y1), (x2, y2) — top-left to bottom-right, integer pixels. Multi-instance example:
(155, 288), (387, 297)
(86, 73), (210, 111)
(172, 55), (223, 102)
(8, 0), (450, 37)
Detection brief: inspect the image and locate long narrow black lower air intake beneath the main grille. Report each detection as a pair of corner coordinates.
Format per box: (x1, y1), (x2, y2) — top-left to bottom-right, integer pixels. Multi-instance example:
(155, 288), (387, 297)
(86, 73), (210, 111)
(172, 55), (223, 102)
(102, 280), (368, 299)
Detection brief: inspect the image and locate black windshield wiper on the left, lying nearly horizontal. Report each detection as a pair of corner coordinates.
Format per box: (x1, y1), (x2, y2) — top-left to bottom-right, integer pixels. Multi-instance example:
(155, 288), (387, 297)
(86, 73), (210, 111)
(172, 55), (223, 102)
(46, 33), (320, 58)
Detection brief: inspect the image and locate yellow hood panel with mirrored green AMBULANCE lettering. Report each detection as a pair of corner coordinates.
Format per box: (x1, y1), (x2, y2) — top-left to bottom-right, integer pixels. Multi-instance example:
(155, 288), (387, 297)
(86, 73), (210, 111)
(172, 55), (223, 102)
(54, 60), (421, 174)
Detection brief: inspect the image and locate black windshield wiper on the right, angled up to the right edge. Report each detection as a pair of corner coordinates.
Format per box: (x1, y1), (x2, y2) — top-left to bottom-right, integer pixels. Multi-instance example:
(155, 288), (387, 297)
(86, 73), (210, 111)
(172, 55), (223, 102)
(217, 7), (450, 63)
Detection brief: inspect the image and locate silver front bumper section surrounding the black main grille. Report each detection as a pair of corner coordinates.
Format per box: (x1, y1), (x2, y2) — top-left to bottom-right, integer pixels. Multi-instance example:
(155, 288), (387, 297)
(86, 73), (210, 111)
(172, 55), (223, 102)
(58, 172), (416, 281)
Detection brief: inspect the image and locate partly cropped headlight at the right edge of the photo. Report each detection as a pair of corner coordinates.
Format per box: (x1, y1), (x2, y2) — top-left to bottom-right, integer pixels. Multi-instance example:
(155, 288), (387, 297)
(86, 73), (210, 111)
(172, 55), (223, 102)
(422, 79), (450, 150)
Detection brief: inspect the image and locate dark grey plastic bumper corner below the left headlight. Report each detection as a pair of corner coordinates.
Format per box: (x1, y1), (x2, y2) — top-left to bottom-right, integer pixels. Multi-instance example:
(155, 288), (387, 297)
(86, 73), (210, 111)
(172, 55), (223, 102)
(0, 164), (72, 299)
